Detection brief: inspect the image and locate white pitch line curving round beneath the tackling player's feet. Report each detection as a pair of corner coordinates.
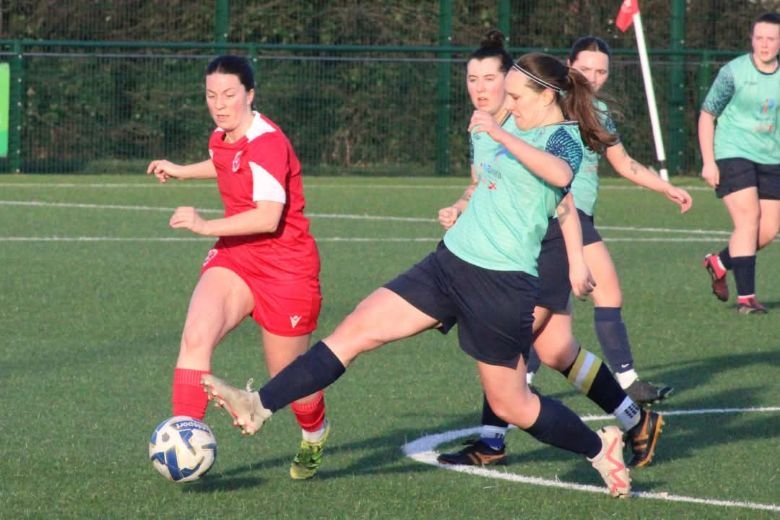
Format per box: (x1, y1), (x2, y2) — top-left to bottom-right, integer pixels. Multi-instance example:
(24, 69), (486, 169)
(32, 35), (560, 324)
(401, 406), (780, 512)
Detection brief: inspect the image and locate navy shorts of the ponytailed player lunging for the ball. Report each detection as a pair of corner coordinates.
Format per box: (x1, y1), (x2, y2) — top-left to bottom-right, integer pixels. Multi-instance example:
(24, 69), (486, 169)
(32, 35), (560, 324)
(385, 242), (539, 368)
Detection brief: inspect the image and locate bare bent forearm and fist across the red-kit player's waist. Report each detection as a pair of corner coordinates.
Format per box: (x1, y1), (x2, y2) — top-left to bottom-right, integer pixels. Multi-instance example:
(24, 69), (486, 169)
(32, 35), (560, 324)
(169, 200), (284, 237)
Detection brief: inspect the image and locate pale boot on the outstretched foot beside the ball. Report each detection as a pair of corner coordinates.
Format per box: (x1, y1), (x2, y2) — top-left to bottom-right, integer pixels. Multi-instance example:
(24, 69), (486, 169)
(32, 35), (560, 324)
(200, 374), (272, 435)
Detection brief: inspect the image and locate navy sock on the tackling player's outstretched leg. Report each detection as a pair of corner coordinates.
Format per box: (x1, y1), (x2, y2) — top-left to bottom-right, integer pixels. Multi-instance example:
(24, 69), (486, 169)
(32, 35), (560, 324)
(260, 341), (345, 412)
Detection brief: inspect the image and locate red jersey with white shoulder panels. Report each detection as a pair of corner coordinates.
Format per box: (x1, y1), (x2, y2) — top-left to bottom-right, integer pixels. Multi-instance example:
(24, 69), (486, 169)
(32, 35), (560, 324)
(209, 112), (320, 281)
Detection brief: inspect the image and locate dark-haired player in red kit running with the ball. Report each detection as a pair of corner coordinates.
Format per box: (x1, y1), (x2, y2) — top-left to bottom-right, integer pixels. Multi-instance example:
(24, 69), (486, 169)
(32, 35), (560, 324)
(147, 56), (330, 479)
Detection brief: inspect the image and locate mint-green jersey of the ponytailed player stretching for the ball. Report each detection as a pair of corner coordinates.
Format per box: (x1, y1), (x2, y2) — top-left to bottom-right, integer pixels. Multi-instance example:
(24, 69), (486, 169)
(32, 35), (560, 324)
(444, 119), (583, 276)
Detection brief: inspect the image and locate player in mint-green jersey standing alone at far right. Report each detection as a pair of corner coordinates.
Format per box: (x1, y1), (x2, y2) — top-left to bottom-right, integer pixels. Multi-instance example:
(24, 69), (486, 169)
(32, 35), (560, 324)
(699, 13), (780, 314)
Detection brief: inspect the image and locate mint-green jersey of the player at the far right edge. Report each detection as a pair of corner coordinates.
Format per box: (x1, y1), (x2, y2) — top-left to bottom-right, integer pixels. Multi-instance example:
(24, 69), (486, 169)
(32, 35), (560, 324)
(701, 54), (780, 164)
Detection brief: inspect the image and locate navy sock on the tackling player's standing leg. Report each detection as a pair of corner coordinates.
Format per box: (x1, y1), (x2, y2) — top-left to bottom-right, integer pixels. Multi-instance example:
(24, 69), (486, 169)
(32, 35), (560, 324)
(525, 395), (601, 459)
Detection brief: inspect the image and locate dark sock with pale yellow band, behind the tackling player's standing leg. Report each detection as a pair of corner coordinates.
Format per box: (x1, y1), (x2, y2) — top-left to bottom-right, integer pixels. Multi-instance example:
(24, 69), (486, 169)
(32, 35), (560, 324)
(561, 348), (626, 414)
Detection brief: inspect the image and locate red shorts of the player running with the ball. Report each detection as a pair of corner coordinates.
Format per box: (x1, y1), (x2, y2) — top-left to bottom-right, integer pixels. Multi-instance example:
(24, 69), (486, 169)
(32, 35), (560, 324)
(201, 248), (322, 337)
